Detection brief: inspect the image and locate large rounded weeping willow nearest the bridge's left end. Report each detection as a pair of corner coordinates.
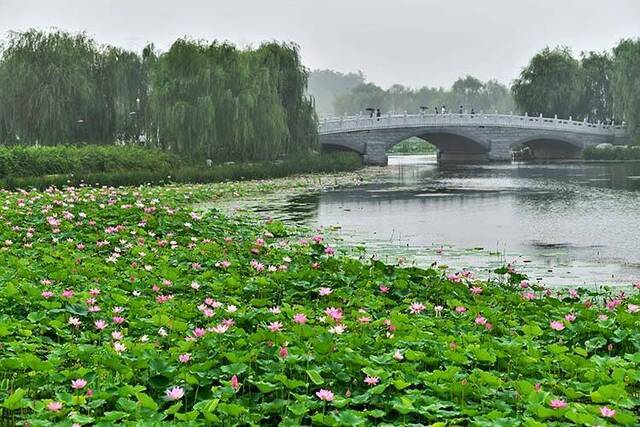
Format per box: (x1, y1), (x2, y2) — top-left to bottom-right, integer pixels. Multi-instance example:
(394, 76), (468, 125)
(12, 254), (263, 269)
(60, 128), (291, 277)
(147, 39), (316, 161)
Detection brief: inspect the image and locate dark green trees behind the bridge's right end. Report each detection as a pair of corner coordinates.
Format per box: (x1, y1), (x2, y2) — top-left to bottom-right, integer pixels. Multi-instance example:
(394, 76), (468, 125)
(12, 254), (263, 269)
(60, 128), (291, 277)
(512, 39), (640, 139)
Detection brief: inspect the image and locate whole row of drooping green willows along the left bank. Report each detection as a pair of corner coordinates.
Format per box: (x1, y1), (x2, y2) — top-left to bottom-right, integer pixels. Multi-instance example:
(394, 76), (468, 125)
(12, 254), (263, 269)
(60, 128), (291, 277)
(0, 30), (317, 161)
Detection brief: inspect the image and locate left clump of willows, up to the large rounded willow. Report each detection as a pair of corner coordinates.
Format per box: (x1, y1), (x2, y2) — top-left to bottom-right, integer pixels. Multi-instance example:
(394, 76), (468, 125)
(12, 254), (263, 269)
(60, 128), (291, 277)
(0, 30), (147, 145)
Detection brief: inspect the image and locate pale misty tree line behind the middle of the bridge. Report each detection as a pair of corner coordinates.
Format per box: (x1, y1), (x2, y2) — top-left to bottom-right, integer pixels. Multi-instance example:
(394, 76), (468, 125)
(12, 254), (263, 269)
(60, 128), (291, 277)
(334, 76), (515, 115)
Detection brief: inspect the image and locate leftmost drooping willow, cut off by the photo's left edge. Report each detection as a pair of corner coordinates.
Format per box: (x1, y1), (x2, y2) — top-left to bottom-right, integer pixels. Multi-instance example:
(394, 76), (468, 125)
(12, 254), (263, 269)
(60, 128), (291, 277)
(0, 30), (97, 145)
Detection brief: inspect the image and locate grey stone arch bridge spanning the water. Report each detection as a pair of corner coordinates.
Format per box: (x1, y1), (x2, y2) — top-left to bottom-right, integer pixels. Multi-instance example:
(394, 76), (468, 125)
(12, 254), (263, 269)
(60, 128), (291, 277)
(318, 113), (629, 165)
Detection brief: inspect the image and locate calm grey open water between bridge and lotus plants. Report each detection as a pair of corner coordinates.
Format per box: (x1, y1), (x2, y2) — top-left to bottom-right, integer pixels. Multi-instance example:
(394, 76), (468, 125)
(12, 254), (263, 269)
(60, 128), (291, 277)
(285, 156), (640, 285)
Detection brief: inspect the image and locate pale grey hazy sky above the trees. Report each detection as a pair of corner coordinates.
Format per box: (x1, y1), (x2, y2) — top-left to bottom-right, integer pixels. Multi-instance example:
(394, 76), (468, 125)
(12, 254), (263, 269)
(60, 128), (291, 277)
(0, 0), (640, 87)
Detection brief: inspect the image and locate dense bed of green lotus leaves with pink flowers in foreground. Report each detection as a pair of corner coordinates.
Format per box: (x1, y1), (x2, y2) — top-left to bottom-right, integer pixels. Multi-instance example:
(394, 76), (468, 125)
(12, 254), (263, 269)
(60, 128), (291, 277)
(0, 179), (640, 426)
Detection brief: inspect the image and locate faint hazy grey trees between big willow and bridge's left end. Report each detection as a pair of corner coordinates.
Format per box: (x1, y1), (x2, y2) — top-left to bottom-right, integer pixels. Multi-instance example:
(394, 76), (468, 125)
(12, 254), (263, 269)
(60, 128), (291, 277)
(308, 70), (365, 114)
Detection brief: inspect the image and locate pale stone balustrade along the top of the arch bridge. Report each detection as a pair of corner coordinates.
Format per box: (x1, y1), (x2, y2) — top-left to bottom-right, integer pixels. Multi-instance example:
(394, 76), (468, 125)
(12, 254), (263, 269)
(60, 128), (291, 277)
(318, 113), (625, 136)
